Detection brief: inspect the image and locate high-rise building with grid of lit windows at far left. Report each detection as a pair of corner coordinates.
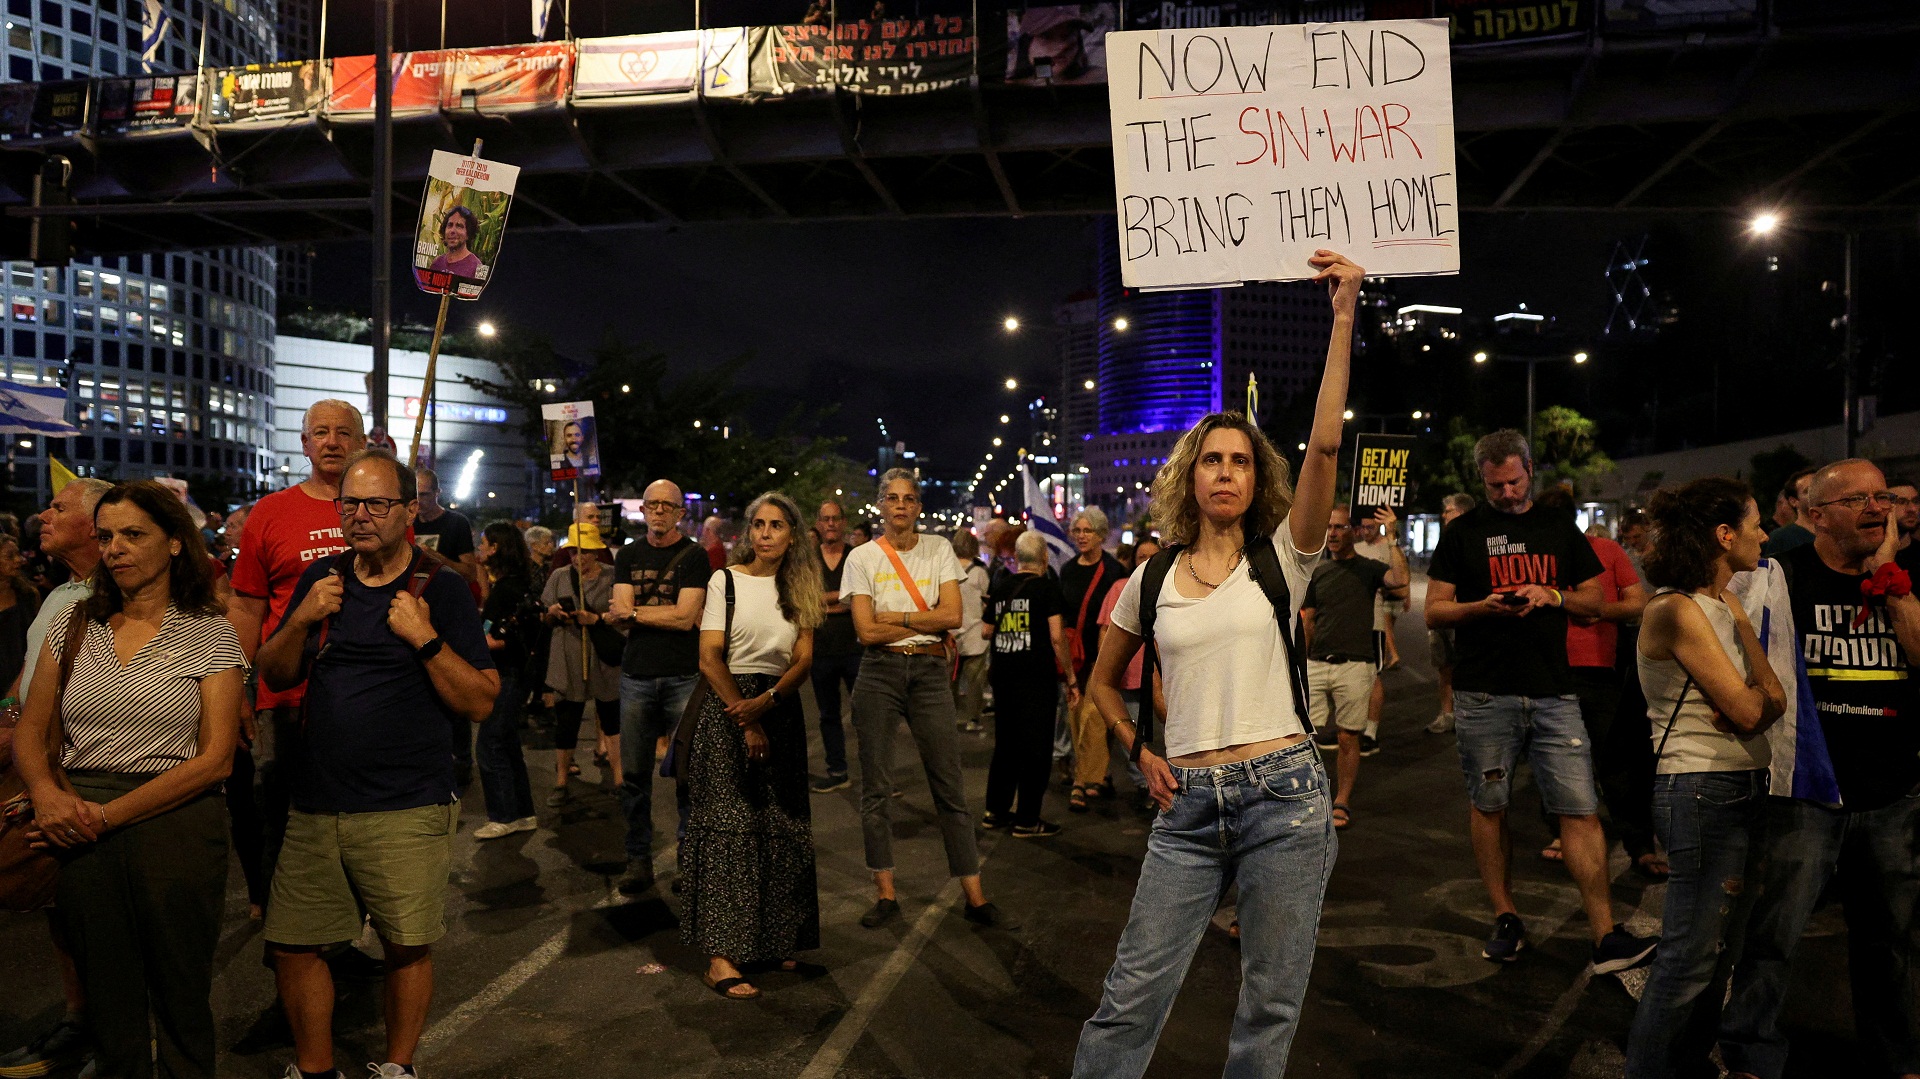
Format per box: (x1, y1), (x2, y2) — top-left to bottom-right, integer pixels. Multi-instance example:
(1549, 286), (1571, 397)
(0, 0), (275, 509)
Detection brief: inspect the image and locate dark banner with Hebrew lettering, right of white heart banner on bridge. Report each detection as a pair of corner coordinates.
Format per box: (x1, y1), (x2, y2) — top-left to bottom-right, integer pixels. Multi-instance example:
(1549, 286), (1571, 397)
(753, 15), (977, 94)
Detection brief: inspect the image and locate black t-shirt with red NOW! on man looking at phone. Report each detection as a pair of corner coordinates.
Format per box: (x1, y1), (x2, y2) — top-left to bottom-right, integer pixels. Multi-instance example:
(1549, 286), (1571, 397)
(1427, 503), (1605, 697)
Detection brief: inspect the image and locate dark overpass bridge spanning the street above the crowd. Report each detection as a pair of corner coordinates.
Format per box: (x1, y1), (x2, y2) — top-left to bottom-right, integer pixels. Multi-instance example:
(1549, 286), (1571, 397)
(0, 15), (1920, 257)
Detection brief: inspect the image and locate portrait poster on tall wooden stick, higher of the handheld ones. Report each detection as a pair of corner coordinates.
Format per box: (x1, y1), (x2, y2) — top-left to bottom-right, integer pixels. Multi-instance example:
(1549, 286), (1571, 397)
(413, 150), (520, 300)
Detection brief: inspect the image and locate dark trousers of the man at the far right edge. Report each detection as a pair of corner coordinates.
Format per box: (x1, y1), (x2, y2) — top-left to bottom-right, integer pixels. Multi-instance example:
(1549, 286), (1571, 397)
(1720, 795), (1920, 1079)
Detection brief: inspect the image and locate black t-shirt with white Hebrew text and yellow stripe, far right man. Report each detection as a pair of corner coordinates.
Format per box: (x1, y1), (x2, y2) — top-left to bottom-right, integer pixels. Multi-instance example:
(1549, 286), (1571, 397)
(1780, 543), (1920, 810)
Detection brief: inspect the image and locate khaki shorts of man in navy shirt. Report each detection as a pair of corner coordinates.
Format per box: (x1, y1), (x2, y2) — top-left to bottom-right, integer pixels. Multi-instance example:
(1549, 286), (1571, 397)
(265, 801), (461, 947)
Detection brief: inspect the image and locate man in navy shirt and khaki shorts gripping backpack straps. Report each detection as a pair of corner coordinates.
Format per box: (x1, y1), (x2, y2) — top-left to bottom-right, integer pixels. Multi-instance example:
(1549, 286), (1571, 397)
(255, 449), (499, 1079)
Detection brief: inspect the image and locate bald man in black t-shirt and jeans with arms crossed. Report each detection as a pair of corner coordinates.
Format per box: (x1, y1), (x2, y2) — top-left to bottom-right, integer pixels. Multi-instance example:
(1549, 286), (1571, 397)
(607, 480), (712, 895)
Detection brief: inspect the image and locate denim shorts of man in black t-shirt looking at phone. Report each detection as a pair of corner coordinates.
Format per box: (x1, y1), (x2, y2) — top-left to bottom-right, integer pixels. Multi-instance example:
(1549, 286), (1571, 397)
(1453, 689), (1599, 816)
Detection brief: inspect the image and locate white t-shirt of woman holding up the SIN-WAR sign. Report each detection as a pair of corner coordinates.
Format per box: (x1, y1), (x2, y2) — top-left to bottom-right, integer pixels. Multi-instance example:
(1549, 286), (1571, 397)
(1112, 520), (1319, 756)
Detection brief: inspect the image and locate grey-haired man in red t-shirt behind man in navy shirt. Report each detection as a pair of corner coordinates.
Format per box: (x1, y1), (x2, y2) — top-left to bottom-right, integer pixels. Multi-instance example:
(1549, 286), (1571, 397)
(227, 401), (367, 925)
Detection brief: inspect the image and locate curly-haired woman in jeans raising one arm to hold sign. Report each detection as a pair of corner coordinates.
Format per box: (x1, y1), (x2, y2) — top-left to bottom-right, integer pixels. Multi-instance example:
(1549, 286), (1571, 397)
(1073, 250), (1365, 1079)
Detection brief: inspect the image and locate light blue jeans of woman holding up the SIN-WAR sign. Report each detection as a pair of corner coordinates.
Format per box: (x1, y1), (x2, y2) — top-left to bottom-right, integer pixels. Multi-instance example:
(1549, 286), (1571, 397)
(1073, 741), (1338, 1079)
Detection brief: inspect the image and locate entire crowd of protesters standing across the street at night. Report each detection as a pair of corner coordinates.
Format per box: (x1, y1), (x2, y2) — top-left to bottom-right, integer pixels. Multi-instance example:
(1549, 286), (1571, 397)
(0, 243), (1920, 1079)
